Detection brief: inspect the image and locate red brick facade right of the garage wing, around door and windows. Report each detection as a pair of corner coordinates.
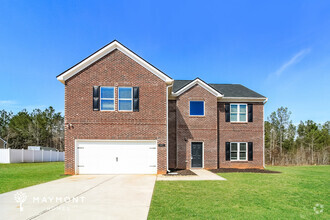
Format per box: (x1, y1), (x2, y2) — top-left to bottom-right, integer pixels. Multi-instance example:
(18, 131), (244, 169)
(169, 85), (264, 169)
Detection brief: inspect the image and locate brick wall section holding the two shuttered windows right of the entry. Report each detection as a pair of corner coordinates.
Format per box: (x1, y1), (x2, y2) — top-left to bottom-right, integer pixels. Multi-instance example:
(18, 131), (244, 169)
(218, 102), (264, 168)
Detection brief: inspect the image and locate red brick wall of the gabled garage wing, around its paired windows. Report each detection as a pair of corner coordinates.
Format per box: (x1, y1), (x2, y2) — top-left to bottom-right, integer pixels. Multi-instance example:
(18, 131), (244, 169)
(65, 50), (166, 174)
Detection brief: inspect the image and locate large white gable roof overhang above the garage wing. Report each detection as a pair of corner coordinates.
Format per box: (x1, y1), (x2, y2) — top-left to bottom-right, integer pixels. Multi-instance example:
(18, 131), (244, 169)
(57, 40), (173, 84)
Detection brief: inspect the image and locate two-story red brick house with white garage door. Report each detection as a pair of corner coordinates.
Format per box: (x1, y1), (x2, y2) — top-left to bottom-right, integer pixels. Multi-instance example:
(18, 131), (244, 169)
(57, 41), (267, 174)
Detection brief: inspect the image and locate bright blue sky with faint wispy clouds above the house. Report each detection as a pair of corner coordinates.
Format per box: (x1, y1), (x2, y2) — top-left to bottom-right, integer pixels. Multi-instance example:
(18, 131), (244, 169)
(0, 0), (330, 123)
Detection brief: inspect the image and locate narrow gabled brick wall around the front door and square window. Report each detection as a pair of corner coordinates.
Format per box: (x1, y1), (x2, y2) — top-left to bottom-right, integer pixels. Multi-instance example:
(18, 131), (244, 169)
(176, 85), (218, 169)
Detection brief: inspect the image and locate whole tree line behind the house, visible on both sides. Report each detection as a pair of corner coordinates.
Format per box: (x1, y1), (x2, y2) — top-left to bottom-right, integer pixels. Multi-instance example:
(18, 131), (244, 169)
(0, 107), (330, 165)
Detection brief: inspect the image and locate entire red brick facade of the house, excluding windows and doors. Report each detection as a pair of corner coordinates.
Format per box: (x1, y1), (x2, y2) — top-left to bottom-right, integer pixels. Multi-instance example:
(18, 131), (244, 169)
(61, 45), (264, 174)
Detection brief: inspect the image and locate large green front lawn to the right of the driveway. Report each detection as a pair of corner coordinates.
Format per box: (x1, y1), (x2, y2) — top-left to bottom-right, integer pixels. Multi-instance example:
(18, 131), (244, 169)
(149, 166), (330, 219)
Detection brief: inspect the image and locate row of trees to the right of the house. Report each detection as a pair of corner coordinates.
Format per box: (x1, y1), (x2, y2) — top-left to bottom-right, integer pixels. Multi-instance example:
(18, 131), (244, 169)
(265, 107), (330, 165)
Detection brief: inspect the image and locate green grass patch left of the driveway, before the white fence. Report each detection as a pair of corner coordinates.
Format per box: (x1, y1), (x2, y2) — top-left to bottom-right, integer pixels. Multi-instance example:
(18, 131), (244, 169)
(0, 162), (64, 193)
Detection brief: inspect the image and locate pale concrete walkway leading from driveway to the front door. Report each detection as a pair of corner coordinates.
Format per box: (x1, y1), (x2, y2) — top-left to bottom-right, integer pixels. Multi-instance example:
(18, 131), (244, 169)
(157, 169), (226, 181)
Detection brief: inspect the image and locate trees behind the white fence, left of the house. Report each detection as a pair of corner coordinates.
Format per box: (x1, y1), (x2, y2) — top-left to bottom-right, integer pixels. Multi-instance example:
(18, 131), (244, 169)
(0, 107), (64, 151)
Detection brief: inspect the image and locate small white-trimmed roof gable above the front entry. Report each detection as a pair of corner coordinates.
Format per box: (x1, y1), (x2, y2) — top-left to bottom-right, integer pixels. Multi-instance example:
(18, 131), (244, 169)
(172, 78), (223, 97)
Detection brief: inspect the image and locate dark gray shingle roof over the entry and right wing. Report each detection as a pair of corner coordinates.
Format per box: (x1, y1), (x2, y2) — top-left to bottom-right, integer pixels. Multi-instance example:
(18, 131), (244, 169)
(173, 80), (265, 98)
